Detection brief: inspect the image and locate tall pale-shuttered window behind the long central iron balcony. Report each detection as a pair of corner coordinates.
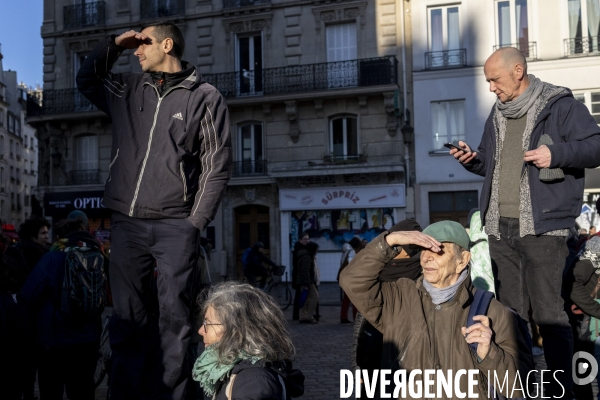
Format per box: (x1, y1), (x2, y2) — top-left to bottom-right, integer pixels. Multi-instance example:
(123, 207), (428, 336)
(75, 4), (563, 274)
(326, 22), (358, 89)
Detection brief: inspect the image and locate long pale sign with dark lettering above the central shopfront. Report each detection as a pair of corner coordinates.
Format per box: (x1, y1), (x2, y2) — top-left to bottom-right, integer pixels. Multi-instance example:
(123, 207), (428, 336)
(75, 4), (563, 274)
(279, 184), (406, 211)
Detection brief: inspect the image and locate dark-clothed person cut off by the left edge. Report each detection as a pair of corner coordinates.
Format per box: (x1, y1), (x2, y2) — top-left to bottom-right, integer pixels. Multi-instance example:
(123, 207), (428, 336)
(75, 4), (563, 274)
(0, 242), (31, 400)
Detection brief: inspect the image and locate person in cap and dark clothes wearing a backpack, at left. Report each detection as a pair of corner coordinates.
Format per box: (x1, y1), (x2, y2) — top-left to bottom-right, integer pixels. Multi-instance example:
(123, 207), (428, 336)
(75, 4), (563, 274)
(22, 211), (102, 400)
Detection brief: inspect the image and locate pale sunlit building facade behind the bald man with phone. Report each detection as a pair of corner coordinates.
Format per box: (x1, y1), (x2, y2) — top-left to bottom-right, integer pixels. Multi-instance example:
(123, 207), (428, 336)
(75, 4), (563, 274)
(412, 0), (600, 228)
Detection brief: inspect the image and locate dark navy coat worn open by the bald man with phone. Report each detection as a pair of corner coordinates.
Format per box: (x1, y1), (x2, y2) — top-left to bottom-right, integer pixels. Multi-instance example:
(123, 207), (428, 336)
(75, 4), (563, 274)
(464, 92), (600, 235)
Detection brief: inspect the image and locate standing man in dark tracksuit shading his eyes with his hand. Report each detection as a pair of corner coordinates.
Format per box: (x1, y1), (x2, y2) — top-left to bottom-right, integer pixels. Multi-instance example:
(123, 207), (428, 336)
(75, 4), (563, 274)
(77, 23), (231, 400)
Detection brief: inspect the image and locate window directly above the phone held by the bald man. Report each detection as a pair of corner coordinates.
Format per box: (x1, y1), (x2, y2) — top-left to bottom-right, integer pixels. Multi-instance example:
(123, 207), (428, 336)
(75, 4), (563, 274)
(431, 100), (465, 152)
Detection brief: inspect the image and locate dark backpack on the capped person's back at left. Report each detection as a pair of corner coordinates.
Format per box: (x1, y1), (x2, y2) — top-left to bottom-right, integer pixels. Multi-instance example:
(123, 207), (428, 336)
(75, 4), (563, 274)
(59, 244), (108, 319)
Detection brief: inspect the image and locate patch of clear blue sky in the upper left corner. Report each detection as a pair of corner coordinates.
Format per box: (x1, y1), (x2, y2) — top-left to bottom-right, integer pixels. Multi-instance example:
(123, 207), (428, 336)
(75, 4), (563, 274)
(0, 0), (44, 87)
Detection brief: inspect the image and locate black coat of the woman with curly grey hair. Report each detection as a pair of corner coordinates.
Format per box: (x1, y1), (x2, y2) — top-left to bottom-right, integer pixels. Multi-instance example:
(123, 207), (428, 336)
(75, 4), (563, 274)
(215, 360), (304, 400)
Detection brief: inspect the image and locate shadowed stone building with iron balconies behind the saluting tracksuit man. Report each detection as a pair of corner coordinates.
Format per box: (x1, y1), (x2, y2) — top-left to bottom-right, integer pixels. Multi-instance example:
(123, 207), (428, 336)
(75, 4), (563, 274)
(28, 0), (414, 280)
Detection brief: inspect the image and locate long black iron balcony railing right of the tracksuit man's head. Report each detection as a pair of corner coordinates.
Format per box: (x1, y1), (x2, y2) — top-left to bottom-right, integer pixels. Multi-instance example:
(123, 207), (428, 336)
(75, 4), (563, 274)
(203, 56), (398, 98)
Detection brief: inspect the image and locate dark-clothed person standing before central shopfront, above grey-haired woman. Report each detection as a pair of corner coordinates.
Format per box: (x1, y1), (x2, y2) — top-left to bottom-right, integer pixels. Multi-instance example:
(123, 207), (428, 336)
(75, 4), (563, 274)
(297, 242), (319, 324)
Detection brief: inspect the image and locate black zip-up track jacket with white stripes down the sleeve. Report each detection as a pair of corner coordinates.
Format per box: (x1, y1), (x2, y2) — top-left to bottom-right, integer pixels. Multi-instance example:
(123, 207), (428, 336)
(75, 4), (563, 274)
(77, 36), (232, 230)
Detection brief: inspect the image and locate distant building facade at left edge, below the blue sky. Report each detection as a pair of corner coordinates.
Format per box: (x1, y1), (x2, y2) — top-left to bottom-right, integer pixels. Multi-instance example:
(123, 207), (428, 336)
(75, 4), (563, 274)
(0, 46), (38, 235)
